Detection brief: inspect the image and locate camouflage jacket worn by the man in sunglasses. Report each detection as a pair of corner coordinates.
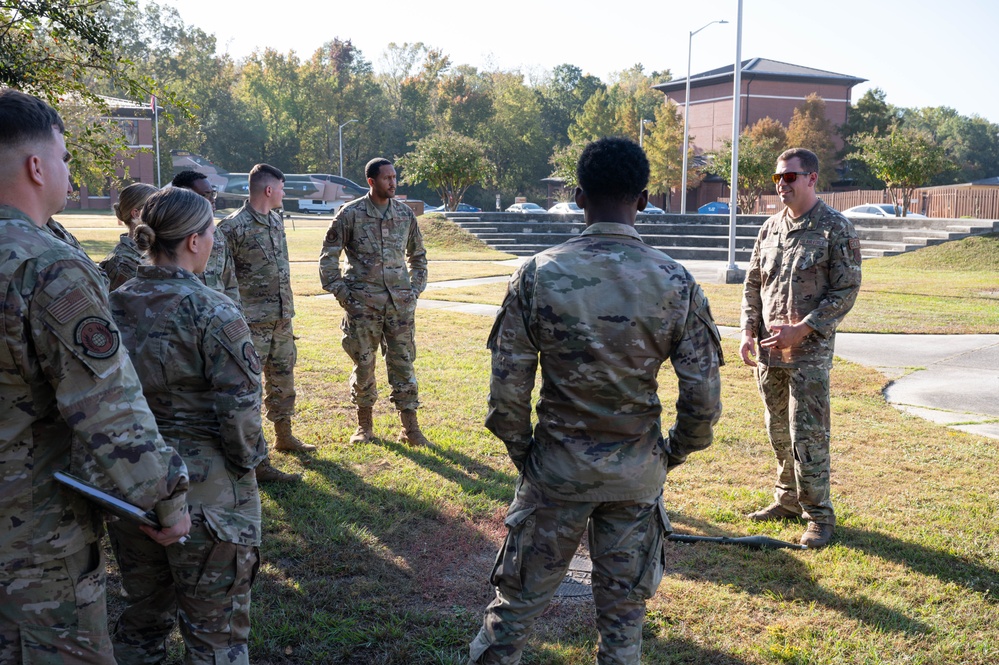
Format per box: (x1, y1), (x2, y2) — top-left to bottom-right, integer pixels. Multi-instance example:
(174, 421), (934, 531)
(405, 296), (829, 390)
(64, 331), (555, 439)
(741, 201), (860, 367)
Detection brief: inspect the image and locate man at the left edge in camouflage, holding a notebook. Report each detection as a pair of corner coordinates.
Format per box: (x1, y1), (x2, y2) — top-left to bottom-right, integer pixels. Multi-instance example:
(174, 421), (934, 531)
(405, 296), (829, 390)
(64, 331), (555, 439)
(0, 90), (191, 663)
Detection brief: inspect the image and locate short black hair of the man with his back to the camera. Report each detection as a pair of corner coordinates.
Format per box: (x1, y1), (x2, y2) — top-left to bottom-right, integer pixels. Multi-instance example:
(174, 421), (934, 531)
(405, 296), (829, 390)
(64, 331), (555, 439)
(576, 137), (649, 203)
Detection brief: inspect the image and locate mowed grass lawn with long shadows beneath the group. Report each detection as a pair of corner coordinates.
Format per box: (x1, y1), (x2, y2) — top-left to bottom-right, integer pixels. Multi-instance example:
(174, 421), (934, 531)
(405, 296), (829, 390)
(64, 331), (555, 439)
(63, 216), (999, 665)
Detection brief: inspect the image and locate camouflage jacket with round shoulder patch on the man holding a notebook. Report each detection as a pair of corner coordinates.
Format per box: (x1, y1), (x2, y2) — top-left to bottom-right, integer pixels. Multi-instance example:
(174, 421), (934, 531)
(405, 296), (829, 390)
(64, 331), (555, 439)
(0, 207), (188, 569)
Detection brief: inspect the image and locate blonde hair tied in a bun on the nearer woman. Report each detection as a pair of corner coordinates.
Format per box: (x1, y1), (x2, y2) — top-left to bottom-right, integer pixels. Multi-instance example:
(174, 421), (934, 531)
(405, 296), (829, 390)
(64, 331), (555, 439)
(134, 187), (215, 259)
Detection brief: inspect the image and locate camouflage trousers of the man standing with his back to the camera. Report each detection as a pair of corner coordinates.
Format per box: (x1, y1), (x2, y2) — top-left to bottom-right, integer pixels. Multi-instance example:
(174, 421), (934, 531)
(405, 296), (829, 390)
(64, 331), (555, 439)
(469, 478), (672, 665)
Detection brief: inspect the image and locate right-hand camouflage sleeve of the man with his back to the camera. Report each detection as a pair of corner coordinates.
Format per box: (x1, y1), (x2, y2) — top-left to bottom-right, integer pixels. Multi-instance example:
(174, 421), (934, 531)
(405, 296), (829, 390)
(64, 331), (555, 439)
(666, 284), (725, 471)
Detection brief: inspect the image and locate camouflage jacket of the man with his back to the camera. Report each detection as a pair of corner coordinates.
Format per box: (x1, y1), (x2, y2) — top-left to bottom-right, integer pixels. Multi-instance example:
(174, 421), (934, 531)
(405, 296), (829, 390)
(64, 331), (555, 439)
(486, 223), (724, 501)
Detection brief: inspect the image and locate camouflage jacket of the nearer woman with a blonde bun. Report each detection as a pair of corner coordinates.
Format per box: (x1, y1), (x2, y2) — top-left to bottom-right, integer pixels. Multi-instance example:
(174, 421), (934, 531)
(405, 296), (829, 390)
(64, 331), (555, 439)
(111, 266), (267, 545)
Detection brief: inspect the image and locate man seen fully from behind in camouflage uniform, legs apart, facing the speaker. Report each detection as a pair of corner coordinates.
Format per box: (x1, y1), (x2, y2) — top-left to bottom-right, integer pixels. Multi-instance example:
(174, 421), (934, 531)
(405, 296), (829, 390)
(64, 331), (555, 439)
(470, 139), (723, 665)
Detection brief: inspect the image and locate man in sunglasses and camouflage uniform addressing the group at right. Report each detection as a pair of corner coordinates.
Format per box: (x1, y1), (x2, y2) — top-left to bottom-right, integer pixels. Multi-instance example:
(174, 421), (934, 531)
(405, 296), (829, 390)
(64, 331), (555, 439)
(739, 148), (860, 547)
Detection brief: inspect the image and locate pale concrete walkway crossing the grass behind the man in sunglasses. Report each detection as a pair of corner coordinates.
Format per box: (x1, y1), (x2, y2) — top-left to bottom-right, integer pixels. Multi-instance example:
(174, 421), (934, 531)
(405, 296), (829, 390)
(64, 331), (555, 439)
(408, 259), (999, 439)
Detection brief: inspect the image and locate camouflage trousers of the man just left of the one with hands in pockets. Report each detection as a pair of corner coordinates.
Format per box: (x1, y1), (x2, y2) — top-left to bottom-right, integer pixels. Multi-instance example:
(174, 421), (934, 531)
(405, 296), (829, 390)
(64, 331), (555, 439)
(250, 319), (298, 422)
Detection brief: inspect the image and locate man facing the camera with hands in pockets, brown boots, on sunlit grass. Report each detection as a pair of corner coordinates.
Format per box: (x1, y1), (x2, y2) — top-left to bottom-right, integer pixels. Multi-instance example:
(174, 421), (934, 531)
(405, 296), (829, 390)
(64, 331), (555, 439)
(319, 157), (429, 446)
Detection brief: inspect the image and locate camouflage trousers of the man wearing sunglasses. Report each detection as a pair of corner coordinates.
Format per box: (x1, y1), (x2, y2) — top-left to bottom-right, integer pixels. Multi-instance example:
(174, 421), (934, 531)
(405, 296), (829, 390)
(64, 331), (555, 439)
(756, 364), (836, 524)
